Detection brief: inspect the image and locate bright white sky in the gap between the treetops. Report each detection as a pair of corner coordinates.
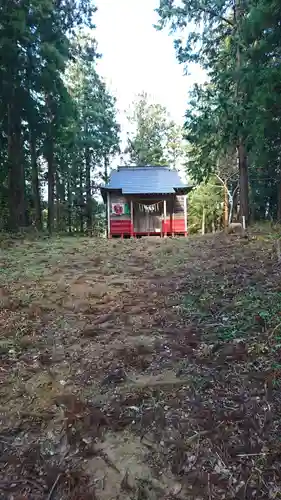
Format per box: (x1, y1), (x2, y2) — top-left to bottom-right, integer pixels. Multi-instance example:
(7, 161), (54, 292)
(94, 0), (204, 137)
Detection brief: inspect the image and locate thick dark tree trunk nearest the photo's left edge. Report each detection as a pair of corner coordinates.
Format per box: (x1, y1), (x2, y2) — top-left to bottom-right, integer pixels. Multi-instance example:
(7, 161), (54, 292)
(7, 100), (26, 231)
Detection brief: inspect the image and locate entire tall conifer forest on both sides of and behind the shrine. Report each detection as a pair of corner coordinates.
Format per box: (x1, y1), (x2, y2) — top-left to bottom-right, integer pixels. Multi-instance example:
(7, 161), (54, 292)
(0, 0), (281, 234)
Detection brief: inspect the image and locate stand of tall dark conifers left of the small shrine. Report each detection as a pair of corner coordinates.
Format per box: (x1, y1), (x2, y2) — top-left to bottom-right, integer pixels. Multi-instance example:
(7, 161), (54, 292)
(0, 0), (119, 234)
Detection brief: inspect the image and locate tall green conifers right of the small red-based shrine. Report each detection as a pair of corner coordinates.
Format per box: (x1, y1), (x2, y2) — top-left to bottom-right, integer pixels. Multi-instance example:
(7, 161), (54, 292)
(158, 0), (281, 227)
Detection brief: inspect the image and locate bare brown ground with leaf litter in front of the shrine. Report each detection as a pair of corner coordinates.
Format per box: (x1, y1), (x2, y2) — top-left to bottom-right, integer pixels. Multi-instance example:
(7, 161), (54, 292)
(0, 234), (281, 500)
